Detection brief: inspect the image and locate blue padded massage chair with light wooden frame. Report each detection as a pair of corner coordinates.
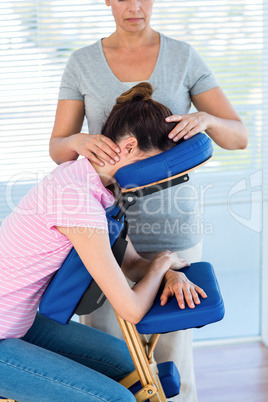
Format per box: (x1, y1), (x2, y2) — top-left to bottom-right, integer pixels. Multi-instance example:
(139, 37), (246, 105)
(35, 133), (224, 402)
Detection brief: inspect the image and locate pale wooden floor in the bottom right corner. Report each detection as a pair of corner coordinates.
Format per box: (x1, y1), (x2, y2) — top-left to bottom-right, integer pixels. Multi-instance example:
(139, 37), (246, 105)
(194, 343), (268, 402)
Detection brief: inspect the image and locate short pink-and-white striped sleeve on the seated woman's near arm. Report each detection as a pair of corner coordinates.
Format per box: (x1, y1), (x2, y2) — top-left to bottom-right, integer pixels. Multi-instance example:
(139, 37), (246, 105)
(45, 162), (108, 231)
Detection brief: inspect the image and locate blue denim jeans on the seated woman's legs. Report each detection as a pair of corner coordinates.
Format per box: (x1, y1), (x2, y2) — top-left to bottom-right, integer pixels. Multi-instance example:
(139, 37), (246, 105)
(0, 314), (135, 402)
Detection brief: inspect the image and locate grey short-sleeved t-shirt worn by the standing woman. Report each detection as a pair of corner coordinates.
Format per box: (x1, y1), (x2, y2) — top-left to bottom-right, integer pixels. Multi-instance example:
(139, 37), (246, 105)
(59, 34), (218, 251)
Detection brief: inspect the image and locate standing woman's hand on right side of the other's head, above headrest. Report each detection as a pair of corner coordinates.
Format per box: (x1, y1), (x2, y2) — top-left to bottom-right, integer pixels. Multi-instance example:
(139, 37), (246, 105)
(166, 112), (211, 142)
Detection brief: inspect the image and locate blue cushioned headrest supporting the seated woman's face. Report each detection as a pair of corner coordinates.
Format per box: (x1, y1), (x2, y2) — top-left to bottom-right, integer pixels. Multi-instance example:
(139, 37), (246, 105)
(115, 133), (213, 189)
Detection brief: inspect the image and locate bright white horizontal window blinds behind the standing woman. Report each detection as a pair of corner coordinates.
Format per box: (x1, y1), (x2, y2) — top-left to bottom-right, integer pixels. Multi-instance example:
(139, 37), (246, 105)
(0, 0), (267, 219)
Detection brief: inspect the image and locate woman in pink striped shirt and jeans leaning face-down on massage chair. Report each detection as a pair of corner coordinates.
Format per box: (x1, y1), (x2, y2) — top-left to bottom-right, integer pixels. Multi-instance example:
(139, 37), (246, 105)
(0, 83), (206, 402)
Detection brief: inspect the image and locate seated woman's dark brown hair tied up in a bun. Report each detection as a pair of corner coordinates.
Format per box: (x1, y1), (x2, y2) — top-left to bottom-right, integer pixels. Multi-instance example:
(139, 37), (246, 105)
(102, 82), (177, 152)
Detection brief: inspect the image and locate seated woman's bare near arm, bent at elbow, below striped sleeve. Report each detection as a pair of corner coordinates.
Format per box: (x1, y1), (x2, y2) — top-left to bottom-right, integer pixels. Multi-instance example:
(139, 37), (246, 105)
(57, 227), (181, 324)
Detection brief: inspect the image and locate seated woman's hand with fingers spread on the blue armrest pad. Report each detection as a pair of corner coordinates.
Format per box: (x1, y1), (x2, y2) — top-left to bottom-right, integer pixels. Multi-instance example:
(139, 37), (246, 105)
(160, 270), (207, 309)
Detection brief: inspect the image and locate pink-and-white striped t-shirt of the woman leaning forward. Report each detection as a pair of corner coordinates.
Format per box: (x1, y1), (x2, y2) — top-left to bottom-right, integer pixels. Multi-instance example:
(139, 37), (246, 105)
(0, 158), (114, 339)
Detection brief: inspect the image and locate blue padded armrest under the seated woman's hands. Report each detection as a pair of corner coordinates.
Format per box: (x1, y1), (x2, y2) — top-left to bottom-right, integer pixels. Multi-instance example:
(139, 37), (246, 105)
(136, 262), (225, 334)
